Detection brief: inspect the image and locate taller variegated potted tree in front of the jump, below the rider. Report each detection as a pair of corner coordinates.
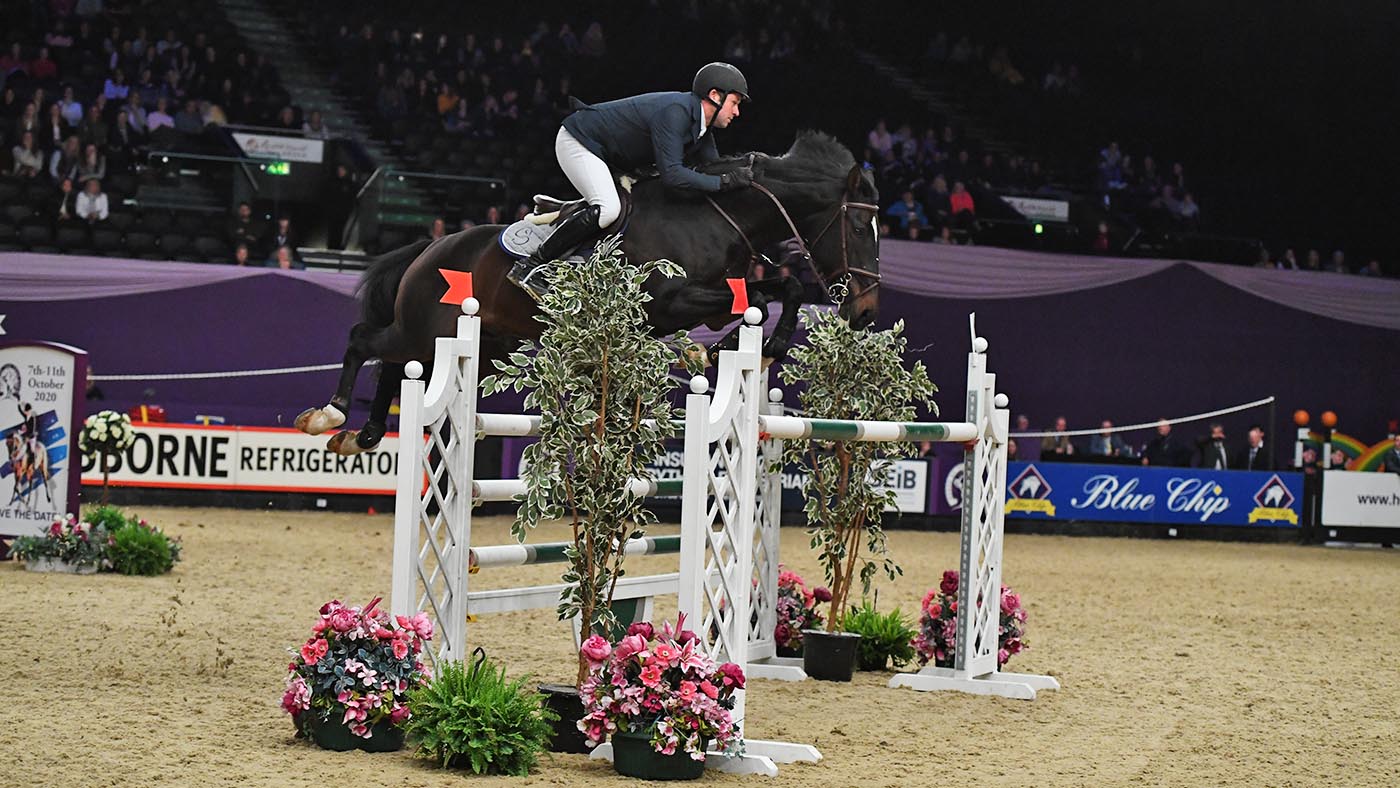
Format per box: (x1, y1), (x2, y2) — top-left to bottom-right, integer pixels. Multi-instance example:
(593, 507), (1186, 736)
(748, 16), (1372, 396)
(482, 237), (694, 752)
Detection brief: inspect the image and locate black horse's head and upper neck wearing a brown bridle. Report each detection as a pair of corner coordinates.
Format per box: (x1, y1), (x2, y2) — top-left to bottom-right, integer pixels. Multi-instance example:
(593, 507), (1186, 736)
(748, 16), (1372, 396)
(762, 132), (879, 328)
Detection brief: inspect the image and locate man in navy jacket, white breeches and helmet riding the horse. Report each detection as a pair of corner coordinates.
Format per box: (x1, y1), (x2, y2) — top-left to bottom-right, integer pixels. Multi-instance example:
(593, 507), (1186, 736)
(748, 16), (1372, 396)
(508, 63), (753, 300)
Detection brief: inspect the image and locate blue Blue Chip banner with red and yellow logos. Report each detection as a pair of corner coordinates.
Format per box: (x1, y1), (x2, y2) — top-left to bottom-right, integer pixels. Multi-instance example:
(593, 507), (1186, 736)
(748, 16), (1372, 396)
(1007, 462), (1303, 528)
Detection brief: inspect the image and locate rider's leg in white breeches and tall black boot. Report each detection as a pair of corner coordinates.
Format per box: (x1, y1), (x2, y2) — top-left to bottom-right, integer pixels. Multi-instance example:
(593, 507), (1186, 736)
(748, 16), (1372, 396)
(510, 129), (622, 298)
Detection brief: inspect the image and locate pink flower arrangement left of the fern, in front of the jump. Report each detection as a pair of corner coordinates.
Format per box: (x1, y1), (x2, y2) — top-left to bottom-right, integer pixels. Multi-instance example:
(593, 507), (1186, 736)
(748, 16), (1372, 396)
(281, 598), (433, 739)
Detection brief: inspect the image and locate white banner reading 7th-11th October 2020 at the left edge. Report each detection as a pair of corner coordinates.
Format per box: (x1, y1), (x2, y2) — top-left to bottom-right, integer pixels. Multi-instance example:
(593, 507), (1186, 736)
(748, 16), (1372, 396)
(0, 342), (87, 536)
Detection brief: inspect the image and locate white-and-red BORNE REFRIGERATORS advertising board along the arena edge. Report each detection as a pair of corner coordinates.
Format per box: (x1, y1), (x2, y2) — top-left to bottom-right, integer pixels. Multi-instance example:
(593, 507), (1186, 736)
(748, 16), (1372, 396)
(83, 424), (399, 495)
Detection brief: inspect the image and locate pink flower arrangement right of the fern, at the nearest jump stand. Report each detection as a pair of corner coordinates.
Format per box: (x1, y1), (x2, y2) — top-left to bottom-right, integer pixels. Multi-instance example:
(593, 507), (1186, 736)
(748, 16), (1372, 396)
(578, 616), (743, 760)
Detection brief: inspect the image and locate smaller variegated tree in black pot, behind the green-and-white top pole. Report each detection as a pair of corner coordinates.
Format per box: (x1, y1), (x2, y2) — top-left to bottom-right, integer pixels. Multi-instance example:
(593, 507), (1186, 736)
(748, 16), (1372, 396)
(780, 309), (938, 682)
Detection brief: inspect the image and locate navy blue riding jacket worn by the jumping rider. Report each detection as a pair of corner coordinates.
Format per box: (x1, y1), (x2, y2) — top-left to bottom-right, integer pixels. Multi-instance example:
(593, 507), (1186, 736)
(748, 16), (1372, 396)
(564, 92), (720, 192)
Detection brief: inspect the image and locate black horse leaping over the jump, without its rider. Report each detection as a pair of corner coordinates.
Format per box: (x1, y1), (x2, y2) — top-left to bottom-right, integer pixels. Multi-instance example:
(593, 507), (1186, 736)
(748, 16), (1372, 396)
(297, 132), (879, 455)
